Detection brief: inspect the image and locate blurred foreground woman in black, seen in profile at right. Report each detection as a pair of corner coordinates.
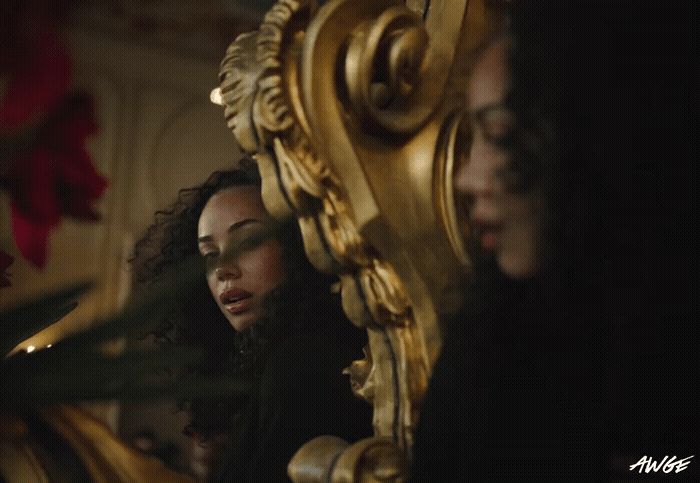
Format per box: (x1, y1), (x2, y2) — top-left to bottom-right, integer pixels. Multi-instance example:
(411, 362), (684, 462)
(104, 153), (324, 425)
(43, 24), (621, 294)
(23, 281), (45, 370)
(413, 2), (697, 481)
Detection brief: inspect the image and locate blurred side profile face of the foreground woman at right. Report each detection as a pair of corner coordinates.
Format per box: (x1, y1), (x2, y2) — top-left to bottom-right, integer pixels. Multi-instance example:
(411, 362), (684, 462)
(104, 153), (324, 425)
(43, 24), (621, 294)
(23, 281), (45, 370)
(455, 39), (544, 278)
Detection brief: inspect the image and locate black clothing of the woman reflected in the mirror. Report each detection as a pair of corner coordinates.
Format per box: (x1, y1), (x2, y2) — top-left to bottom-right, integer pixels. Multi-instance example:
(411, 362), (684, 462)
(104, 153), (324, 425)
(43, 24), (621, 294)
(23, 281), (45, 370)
(216, 320), (372, 482)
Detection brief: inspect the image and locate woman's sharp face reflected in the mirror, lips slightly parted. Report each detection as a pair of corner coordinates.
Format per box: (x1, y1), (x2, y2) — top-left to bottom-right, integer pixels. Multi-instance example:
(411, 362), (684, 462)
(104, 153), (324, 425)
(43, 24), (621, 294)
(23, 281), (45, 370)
(198, 186), (285, 332)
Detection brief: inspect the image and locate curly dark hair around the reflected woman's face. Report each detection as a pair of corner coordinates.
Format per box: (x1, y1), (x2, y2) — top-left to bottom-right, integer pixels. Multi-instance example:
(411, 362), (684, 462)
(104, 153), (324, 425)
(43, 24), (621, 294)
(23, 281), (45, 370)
(131, 159), (342, 437)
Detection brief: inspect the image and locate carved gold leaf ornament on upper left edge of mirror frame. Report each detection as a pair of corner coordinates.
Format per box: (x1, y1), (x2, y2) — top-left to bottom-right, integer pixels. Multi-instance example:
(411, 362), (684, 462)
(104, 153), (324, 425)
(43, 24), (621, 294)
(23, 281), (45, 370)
(219, 0), (329, 217)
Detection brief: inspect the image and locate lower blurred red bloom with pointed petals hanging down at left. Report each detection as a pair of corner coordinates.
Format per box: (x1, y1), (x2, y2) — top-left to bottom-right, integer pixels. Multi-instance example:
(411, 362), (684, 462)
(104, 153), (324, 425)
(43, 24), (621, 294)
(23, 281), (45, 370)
(0, 95), (107, 267)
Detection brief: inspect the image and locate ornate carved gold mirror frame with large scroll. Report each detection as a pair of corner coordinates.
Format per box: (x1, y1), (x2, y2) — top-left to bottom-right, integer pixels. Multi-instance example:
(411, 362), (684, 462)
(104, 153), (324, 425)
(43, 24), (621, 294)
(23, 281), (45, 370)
(212, 0), (497, 481)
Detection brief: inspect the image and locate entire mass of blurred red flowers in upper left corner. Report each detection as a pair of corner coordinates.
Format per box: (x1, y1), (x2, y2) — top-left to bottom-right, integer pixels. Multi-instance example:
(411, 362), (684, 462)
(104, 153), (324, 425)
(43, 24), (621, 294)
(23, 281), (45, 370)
(0, 0), (107, 267)
